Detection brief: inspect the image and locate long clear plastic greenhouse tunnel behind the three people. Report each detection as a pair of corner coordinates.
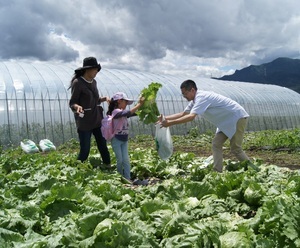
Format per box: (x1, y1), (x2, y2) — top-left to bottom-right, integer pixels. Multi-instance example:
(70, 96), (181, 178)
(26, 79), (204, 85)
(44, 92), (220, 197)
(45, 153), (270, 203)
(0, 61), (300, 146)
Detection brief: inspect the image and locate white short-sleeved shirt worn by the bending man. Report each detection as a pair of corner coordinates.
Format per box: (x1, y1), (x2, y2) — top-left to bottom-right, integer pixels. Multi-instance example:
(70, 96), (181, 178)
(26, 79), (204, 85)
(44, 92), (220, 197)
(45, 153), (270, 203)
(184, 90), (249, 139)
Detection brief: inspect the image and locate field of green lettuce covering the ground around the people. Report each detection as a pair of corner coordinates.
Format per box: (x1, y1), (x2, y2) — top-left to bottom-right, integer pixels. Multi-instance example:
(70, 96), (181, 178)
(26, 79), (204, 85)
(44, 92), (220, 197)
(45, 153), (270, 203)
(0, 130), (300, 248)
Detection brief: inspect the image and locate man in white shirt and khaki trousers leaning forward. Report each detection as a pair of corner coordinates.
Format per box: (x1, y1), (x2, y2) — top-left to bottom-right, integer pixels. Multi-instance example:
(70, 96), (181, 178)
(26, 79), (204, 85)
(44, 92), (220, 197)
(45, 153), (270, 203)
(160, 80), (250, 172)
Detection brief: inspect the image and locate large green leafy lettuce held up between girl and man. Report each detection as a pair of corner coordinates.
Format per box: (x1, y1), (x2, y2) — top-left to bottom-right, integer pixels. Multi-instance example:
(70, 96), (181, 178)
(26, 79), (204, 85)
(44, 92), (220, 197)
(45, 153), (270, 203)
(136, 82), (162, 124)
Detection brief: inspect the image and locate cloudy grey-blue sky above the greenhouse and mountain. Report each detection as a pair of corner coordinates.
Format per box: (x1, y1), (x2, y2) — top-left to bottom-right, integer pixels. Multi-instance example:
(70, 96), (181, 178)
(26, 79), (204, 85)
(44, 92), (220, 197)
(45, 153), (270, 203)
(0, 0), (300, 78)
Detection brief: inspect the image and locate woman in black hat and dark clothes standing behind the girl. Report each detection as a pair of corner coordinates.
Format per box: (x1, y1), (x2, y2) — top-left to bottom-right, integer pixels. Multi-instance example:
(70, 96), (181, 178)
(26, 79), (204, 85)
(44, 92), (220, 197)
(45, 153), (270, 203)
(69, 57), (111, 166)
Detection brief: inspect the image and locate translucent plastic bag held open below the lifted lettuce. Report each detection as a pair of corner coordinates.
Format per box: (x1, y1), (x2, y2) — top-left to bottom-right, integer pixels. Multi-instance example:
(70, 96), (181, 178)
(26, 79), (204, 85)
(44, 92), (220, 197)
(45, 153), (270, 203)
(155, 124), (173, 160)
